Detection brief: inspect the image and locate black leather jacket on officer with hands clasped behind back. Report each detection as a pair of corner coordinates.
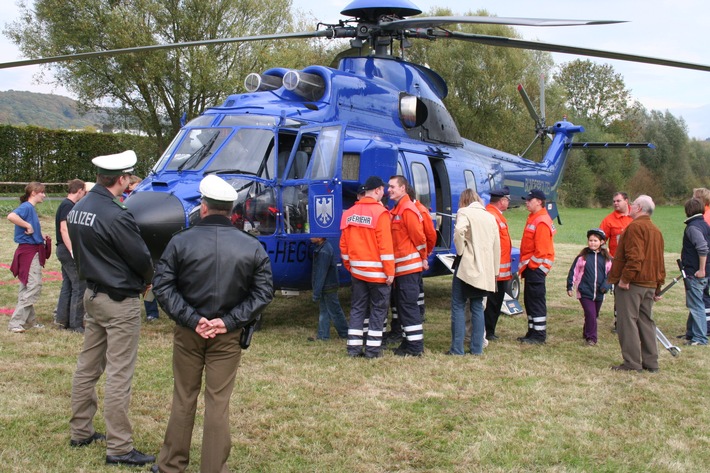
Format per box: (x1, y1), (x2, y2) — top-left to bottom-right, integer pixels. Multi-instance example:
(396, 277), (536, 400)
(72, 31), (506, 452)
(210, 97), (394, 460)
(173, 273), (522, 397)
(153, 215), (274, 331)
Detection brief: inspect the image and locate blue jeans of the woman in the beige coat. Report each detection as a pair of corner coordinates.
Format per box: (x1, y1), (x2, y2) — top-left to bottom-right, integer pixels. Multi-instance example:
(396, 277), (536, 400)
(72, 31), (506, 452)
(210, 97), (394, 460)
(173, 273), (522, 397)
(450, 276), (485, 355)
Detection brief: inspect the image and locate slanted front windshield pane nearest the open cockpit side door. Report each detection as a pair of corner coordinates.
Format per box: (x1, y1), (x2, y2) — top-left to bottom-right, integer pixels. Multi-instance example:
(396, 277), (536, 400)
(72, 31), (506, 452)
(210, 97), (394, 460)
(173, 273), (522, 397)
(206, 128), (274, 179)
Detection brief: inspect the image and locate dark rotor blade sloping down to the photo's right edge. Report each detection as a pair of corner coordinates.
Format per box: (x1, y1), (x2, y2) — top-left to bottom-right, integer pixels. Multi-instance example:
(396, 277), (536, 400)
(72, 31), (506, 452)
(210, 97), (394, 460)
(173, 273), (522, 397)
(428, 30), (710, 72)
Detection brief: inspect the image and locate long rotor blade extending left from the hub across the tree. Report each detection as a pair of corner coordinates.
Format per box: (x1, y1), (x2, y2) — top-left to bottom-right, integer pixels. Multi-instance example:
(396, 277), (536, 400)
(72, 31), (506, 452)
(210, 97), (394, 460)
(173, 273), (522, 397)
(0, 28), (340, 69)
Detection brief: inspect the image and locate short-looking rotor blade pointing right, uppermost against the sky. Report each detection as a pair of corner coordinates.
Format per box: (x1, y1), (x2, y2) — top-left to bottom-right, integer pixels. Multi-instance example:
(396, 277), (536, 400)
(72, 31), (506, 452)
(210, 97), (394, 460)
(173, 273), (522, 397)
(380, 16), (626, 30)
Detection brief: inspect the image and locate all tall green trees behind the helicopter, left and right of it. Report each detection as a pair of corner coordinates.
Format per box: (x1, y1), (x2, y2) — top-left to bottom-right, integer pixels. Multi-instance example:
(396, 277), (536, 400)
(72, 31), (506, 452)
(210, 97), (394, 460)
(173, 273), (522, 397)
(5, 0), (710, 207)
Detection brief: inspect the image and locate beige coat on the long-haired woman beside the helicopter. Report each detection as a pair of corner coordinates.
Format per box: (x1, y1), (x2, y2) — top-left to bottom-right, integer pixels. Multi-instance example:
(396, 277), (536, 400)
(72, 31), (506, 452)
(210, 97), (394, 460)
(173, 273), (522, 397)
(454, 202), (500, 292)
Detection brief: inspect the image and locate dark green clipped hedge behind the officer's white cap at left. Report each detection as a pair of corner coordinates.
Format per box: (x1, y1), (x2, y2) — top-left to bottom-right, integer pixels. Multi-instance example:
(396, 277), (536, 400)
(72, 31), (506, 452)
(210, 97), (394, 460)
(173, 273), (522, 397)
(0, 125), (160, 192)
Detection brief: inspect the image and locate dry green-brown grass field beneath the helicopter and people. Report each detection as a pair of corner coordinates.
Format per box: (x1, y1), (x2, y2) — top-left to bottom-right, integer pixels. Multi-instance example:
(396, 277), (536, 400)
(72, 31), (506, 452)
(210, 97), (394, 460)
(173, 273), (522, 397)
(0, 202), (710, 472)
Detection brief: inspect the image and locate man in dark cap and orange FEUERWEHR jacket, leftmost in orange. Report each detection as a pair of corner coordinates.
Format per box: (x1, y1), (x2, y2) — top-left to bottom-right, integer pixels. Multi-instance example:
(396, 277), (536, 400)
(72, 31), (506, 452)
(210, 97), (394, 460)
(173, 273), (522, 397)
(340, 176), (395, 358)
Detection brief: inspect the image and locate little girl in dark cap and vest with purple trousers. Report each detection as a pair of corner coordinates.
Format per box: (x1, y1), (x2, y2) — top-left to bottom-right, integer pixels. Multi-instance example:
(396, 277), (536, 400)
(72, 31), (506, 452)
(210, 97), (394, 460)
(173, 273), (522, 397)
(567, 228), (611, 346)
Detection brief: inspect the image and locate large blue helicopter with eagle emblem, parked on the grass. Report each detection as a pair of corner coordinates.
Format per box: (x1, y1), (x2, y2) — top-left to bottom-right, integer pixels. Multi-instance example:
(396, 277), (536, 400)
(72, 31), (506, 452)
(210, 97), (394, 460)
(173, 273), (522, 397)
(0, 0), (710, 296)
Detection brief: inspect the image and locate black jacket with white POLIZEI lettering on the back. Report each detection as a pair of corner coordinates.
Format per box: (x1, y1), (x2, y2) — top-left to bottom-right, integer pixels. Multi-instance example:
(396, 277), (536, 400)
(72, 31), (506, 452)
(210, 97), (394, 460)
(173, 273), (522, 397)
(67, 184), (153, 300)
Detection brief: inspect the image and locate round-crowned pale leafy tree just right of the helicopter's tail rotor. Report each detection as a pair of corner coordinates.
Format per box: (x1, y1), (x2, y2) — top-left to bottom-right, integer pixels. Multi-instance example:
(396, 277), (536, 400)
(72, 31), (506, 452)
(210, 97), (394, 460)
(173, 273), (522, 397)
(555, 59), (630, 126)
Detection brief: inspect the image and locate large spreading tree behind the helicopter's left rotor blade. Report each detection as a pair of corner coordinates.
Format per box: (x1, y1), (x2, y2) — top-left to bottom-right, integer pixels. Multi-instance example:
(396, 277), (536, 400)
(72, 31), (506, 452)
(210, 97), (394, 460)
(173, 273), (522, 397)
(5, 0), (318, 149)
